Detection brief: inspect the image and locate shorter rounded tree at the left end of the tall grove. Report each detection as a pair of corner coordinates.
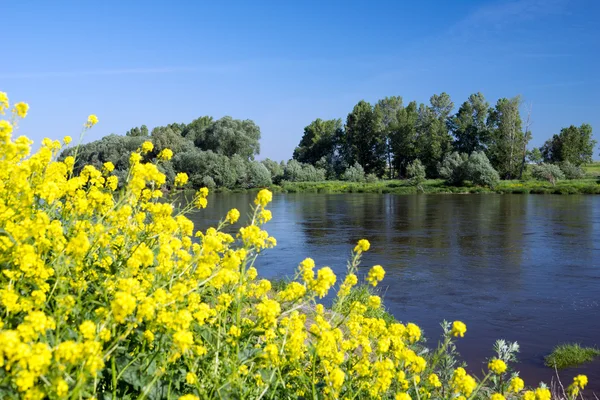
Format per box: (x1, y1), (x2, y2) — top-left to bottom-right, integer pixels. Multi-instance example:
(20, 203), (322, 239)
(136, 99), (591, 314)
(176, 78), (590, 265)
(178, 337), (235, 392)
(293, 118), (343, 165)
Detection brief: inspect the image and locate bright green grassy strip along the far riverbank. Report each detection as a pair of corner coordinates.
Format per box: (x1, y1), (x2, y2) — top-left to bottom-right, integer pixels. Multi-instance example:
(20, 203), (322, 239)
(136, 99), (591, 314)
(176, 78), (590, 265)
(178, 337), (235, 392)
(274, 178), (600, 194)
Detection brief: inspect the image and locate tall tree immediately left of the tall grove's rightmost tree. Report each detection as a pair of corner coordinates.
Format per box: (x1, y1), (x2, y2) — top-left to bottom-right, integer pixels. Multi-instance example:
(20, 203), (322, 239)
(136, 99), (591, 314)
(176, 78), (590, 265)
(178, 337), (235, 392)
(448, 93), (490, 154)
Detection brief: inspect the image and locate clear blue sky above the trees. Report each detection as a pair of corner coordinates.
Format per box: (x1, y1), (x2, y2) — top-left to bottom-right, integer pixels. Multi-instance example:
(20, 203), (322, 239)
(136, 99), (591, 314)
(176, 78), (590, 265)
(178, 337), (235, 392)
(0, 0), (600, 160)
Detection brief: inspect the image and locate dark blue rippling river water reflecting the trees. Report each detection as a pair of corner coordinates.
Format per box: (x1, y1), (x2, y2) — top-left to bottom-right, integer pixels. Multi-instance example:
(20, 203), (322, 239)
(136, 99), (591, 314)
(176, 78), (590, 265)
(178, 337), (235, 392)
(192, 193), (600, 393)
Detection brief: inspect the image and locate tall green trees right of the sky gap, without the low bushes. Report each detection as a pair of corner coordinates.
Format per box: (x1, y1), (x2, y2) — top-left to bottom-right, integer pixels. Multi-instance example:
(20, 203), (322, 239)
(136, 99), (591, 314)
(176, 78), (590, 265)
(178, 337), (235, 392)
(293, 93), (596, 183)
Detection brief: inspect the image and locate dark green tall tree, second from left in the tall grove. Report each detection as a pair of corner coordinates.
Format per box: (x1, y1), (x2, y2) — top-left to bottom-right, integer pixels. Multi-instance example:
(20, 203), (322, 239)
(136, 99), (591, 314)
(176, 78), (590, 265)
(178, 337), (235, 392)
(342, 100), (385, 176)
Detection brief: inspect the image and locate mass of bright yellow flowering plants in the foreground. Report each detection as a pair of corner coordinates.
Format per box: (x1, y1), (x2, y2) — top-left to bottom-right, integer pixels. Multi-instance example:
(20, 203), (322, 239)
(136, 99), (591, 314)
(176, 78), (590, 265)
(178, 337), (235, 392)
(0, 93), (587, 400)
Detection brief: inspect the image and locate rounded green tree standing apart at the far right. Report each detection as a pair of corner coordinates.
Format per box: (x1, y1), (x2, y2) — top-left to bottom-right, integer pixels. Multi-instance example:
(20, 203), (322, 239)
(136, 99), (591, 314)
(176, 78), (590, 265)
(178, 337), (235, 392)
(541, 124), (596, 166)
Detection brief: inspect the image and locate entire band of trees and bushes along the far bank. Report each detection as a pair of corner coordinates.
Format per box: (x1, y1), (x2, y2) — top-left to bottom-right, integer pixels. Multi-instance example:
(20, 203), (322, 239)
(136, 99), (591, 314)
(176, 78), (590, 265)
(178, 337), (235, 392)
(61, 93), (596, 189)
